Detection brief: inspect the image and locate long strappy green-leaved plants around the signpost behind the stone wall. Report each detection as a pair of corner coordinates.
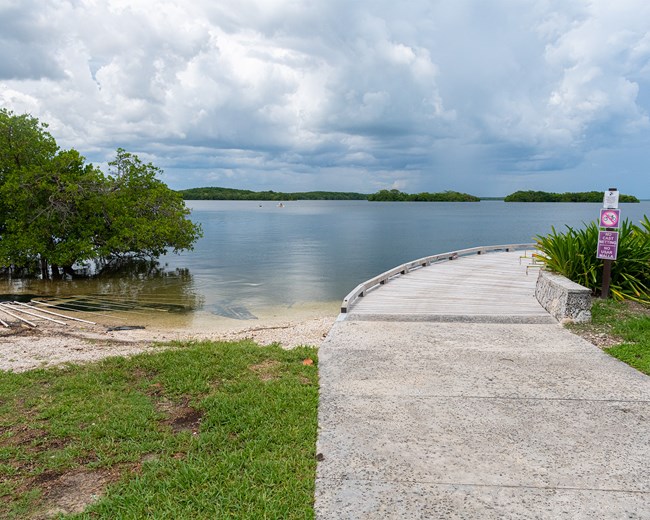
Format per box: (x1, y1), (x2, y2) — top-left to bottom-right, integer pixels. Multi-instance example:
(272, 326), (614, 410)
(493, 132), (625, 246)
(536, 216), (650, 302)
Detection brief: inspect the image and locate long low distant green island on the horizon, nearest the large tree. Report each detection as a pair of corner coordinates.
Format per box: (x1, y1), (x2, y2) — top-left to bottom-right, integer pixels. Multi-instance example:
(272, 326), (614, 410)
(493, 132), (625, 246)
(178, 187), (367, 201)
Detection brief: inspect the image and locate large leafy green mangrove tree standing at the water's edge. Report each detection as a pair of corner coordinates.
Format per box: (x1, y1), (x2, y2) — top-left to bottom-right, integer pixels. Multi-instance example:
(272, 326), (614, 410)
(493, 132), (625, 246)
(0, 110), (201, 276)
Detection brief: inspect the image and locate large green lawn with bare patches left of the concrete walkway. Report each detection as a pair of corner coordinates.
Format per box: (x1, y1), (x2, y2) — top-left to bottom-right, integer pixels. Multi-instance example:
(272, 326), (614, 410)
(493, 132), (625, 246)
(0, 341), (318, 519)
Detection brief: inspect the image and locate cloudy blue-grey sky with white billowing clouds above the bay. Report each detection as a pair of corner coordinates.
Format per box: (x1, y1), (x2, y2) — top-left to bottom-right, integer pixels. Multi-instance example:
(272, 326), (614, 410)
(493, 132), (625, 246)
(0, 0), (650, 198)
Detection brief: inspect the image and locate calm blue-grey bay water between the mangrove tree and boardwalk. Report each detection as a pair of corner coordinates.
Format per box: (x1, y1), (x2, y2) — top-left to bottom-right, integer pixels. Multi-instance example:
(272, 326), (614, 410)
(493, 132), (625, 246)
(0, 201), (650, 326)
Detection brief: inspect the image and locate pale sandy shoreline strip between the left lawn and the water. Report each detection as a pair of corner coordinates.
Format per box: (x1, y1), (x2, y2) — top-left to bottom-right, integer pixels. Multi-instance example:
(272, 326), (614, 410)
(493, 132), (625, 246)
(0, 313), (336, 372)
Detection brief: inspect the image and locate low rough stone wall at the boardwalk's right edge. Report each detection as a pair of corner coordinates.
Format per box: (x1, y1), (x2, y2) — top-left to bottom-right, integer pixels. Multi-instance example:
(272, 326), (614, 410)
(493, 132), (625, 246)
(535, 269), (591, 323)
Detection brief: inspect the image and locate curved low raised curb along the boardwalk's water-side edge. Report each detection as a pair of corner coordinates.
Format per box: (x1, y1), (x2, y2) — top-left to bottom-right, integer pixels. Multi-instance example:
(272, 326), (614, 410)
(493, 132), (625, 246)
(341, 243), (535, 313)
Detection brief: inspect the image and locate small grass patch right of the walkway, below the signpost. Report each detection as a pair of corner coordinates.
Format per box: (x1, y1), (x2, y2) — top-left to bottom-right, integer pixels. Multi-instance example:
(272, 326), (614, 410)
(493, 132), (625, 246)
(572, 300), (650, 375)
